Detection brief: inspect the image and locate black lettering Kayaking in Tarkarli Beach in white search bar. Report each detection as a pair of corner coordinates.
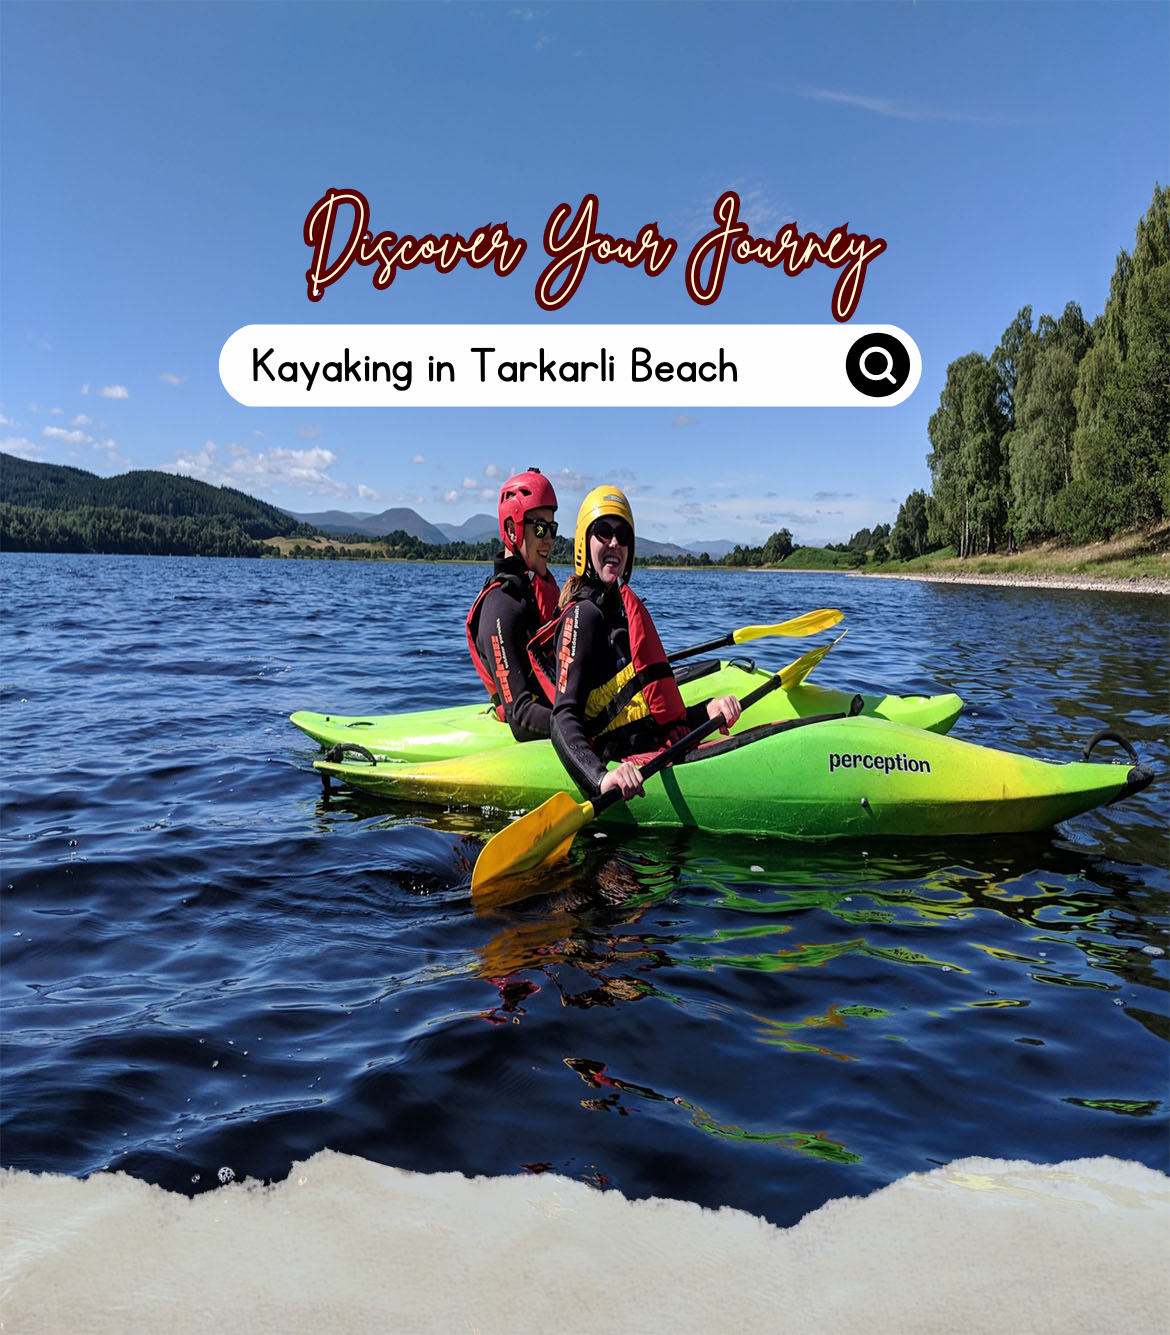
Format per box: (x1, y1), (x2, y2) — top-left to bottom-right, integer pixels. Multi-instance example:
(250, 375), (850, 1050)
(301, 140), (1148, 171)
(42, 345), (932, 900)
(252, 346), (739, 394)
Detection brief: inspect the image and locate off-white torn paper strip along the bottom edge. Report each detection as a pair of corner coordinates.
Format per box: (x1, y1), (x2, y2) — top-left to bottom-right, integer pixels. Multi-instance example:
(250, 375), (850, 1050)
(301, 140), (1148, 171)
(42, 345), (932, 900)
(0, 1151), (1170, 1335)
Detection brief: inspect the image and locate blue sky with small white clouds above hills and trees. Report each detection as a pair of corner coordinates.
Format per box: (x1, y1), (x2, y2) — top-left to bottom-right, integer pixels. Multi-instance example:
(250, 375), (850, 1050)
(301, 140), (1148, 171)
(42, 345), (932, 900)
(0, 0), (1170, 543)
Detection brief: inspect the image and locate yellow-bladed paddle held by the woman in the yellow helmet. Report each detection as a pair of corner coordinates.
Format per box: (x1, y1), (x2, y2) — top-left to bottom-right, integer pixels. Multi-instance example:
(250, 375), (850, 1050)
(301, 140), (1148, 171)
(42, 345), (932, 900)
(471, 631), (847, 902)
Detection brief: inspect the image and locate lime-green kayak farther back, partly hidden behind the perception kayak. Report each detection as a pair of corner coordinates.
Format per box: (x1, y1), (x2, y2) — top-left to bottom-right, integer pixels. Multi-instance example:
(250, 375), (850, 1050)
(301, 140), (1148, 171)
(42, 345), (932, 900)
(291, 661), (963, 761)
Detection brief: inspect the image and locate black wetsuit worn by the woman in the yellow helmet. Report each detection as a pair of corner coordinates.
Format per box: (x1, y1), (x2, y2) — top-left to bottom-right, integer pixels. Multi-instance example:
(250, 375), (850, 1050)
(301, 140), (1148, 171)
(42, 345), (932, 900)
(552, 579), (707, 797)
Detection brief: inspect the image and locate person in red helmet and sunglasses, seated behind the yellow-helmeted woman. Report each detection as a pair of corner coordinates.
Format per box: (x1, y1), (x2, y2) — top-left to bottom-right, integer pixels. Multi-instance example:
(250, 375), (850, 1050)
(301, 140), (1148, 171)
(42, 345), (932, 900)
(467, 469), (558, 742)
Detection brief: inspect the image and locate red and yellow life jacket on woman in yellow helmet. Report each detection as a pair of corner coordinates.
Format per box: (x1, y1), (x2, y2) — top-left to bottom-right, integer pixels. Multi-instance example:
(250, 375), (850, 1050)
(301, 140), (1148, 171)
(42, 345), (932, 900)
(528, 585), (687, 741)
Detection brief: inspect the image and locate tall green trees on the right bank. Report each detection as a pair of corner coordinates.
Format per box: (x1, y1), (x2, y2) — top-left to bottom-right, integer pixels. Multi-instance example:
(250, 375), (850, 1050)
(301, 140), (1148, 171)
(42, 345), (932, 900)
(888, 186), (1170, 561)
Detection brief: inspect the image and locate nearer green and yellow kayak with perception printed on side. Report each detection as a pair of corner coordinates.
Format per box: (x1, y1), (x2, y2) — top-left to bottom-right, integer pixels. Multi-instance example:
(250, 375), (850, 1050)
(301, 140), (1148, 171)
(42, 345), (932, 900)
(317, 715), (1151, 840)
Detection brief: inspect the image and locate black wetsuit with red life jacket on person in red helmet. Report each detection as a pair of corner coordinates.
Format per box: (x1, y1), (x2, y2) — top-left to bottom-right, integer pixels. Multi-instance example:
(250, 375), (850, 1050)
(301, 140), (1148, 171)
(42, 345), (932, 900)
(475, 553), (552, 742)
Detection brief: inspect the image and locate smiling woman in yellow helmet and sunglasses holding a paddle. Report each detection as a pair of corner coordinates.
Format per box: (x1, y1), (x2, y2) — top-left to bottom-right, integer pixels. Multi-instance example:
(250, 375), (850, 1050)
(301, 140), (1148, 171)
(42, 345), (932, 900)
(529, 486), (740, 797)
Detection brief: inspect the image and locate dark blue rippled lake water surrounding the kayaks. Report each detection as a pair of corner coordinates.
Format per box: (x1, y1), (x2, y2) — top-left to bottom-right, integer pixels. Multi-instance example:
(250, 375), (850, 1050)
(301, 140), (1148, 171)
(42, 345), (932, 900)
(0, 554), (1170, 1224)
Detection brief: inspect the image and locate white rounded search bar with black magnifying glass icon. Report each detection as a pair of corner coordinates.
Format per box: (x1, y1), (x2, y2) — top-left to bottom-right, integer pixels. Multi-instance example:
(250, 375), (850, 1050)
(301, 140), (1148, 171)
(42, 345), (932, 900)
(219, 324), (922, 407)
